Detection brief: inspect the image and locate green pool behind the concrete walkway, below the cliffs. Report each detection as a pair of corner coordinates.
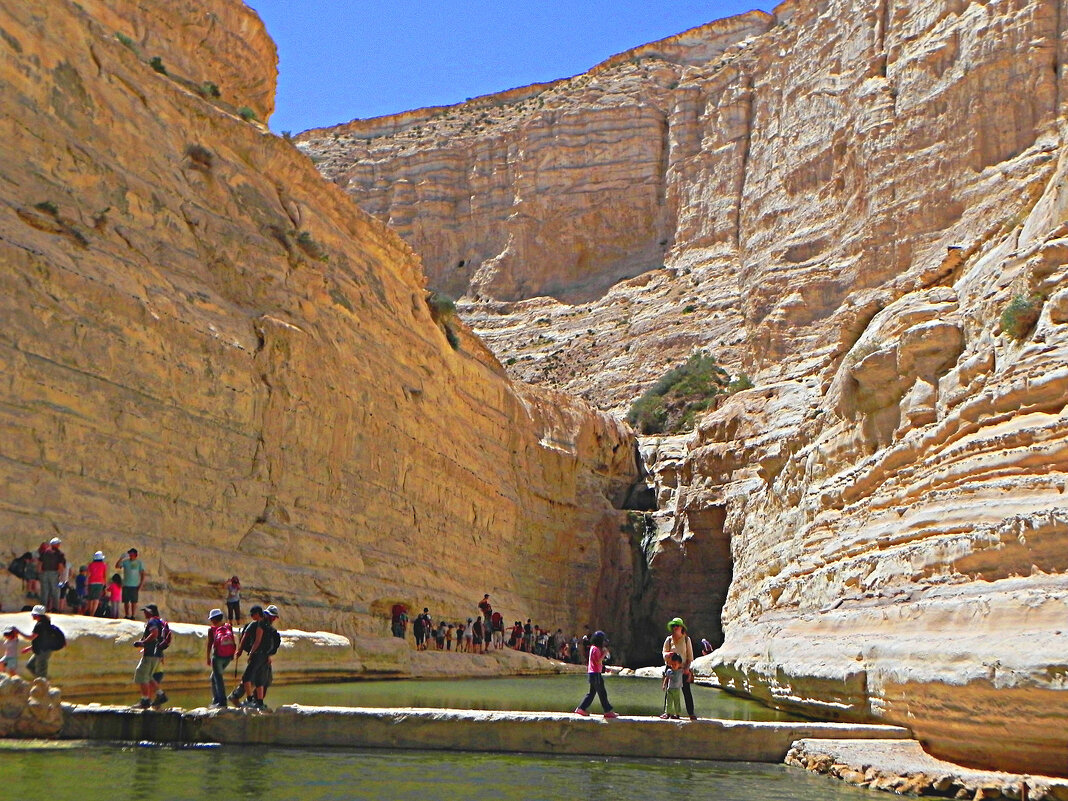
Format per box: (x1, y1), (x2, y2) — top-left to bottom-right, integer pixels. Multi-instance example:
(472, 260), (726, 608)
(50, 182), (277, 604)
(93, 674), (802, 721)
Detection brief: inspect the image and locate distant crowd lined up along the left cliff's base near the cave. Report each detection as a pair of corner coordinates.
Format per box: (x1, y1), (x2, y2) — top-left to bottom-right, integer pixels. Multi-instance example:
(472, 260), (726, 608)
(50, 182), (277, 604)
(390, 593), (590, 664)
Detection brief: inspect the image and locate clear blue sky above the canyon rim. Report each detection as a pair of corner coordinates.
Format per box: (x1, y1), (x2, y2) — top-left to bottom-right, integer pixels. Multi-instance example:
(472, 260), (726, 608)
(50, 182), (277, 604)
(246, 0), (775, 134)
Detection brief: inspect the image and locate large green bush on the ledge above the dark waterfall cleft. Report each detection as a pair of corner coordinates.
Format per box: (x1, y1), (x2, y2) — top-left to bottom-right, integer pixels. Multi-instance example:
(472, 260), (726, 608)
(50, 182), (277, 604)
(627, 354), (739, 434)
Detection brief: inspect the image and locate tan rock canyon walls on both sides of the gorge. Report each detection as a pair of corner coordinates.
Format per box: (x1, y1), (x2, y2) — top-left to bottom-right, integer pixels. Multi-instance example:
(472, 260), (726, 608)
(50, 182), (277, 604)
(0, 0), (1068, 775)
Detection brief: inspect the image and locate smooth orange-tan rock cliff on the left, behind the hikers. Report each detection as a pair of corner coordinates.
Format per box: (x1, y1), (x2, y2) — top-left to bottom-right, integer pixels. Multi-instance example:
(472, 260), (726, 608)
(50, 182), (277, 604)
(0, 0), (637, 657)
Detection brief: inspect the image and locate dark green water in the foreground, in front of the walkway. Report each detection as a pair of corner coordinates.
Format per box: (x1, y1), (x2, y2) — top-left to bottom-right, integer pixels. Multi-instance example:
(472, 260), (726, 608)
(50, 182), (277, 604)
(0, 744), (881, 801)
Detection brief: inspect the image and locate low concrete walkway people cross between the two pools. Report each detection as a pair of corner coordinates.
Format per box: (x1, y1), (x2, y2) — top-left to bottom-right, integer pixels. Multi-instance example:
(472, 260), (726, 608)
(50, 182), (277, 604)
(61, 705), (911, 763)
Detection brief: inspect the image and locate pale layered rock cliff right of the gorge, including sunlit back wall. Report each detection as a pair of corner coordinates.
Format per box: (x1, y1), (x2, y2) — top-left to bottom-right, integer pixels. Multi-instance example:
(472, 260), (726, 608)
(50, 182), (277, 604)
(301, 0), (1068, 774)
